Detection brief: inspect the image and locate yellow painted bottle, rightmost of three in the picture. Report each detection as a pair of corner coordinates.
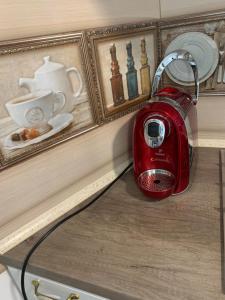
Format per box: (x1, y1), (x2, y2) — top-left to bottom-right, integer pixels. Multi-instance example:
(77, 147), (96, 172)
(140, 39), (151, 95)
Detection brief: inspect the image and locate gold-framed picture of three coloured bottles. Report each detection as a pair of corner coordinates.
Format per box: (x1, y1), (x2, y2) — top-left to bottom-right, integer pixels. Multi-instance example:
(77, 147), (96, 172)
(87, 22), (157, 123)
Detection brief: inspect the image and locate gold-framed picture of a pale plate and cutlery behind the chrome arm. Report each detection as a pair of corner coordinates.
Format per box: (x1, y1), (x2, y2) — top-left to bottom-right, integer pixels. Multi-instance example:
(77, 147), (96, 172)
(159, 12), (225, 96)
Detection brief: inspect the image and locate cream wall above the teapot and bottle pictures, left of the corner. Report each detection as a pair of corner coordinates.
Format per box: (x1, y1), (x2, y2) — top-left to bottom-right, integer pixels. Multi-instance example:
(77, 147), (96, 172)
(0, 0), (159, 40)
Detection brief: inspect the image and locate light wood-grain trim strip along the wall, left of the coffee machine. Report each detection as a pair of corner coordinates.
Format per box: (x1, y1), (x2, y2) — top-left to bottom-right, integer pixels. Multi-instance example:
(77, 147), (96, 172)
(0, 153), (130, 254)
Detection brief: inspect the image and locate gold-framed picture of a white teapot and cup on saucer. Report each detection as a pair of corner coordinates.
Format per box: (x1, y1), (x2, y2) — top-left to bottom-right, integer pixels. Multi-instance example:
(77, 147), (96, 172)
(0, 32), (98, 169)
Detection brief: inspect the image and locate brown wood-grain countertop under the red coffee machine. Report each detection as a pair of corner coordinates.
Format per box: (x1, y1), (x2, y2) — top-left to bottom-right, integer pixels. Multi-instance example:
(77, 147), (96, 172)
(0, 148), (225, 300)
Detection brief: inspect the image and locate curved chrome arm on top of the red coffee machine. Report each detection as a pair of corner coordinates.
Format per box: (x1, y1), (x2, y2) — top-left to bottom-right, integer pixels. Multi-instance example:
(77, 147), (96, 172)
(152, 49), (199, 104)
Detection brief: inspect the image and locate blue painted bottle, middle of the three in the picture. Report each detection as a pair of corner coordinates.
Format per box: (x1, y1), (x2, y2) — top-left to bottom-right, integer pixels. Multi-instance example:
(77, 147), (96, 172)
(126, 42), (139, 100)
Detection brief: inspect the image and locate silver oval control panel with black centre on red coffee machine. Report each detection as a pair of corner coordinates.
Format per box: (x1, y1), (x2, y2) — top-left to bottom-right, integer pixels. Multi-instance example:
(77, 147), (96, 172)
(144, 119), (166, 148)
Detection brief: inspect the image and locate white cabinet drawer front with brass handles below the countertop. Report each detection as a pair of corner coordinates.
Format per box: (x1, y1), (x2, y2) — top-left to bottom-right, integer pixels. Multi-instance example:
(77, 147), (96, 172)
(8, 267), (109, 300)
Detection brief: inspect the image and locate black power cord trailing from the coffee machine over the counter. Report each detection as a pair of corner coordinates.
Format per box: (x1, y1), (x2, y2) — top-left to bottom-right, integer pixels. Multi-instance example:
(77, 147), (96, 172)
(21, 163), (133, 300)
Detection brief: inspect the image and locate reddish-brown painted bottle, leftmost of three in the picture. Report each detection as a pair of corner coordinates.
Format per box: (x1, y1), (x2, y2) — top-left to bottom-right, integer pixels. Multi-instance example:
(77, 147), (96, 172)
(110, 44), (125, 106)
